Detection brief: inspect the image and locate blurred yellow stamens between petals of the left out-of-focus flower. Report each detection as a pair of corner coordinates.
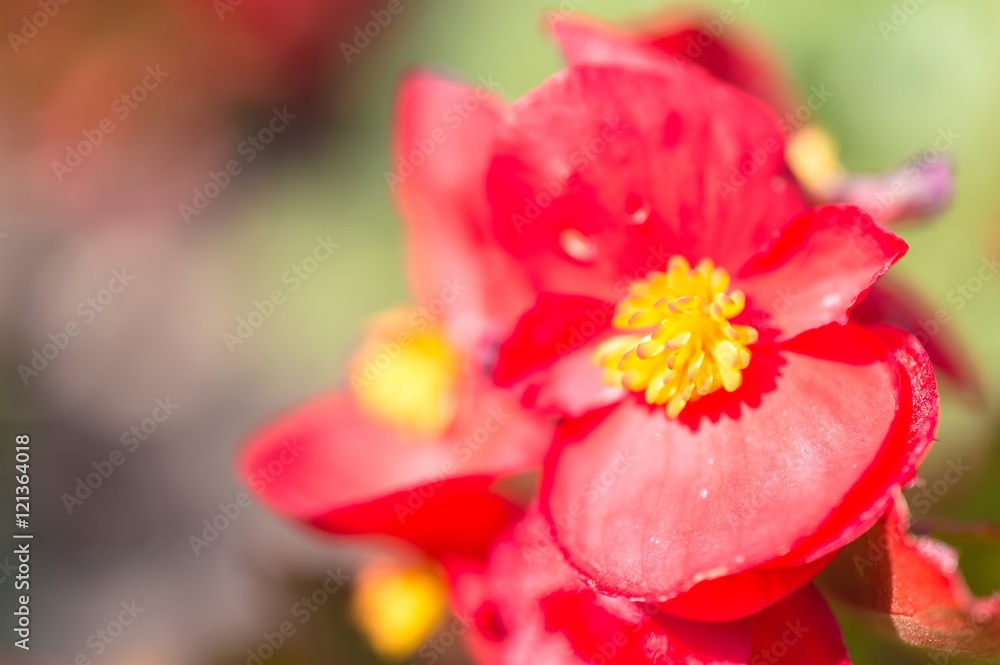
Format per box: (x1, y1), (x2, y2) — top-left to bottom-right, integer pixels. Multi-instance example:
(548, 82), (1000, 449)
(351, 311), (461, 436)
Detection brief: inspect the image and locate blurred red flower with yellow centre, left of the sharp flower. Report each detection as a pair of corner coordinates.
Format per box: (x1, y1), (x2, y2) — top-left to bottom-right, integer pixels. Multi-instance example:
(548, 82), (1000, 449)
(241, 75), (551, 558)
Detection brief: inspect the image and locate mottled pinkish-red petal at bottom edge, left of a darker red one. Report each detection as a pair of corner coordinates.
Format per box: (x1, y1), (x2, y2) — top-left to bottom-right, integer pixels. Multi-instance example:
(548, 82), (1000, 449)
(458, 513), (750, 665)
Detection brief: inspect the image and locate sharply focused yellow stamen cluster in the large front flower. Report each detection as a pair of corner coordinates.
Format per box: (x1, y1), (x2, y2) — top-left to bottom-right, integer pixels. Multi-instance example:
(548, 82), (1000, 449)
(595, 256), (757, 418)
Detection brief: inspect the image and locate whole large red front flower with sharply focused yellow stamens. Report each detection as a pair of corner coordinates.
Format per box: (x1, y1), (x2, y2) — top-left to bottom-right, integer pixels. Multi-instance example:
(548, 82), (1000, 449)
(487, 57), (937, 620)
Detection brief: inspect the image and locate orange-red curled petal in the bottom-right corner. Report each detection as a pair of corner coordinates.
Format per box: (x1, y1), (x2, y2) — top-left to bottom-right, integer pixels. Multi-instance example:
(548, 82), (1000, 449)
(825, 496), (1000, 658)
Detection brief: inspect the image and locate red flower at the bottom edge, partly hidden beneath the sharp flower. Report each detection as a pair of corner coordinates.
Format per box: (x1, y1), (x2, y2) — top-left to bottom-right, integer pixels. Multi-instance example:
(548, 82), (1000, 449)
(453, 512), (850, 665)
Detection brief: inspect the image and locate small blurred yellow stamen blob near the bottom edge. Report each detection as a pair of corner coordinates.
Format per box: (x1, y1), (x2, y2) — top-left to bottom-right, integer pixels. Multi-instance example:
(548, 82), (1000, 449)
(352, 563), (448, 660)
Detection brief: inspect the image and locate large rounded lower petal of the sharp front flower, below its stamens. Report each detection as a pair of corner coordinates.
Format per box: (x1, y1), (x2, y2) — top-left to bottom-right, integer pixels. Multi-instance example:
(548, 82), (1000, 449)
(542, 325), (936, 612)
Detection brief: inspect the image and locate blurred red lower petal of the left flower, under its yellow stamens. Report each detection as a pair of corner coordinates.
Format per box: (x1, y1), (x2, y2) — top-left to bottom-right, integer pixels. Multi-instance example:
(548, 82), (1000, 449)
(240, 389), (548, 557)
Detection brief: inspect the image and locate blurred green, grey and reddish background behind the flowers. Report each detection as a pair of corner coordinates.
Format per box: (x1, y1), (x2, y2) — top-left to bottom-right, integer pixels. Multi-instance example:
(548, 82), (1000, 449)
(0, 0), (1000, 665)
